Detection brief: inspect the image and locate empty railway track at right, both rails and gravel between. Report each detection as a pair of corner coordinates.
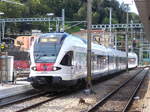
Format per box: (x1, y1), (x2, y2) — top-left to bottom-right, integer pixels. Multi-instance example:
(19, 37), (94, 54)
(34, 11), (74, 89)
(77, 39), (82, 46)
(87, 69), (148, 112)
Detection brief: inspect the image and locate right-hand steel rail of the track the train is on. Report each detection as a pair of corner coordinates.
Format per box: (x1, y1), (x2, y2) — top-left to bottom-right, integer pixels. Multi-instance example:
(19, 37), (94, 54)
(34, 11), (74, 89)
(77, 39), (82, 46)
(16, 95), (62, 112)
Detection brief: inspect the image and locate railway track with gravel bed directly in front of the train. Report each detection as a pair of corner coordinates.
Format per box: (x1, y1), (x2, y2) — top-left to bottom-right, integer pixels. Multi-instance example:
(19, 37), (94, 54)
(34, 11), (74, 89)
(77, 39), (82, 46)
(0, 88), (73, 112)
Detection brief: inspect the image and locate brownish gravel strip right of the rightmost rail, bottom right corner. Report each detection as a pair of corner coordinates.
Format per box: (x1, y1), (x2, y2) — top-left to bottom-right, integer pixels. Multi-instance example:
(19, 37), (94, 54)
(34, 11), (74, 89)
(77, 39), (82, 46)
(129, 68), (150, 112)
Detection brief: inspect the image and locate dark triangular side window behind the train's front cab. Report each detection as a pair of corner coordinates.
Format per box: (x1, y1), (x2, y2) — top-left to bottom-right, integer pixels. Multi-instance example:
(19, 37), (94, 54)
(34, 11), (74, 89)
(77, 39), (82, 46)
(60, 51), (73, 66)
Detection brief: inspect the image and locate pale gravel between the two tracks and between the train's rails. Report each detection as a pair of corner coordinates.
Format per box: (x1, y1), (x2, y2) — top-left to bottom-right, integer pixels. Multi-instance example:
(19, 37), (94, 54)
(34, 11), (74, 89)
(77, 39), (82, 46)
(0, 70), (137, 112)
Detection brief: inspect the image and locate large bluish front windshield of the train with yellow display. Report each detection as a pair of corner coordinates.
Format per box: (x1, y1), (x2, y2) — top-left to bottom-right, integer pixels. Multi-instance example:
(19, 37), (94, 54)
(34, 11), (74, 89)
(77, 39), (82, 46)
(34, 37), (61, 63)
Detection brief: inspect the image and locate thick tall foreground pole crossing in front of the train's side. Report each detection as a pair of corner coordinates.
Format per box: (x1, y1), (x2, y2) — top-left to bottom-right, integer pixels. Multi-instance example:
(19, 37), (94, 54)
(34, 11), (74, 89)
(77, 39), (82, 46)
(87, 0), (92, 92)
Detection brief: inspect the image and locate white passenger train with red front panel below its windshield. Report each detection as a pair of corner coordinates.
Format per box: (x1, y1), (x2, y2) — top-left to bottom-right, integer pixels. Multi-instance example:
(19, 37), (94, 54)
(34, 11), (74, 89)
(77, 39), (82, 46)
(29, 33), (138, 89)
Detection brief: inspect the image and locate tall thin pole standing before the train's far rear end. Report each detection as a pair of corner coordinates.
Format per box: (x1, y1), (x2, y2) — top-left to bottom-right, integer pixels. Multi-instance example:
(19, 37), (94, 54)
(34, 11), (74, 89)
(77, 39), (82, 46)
(126, 4), (129, 72)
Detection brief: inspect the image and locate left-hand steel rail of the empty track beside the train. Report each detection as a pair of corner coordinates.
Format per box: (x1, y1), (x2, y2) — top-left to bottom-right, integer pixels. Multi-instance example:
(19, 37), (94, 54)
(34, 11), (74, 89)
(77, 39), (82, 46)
(87, 69), (143, 112)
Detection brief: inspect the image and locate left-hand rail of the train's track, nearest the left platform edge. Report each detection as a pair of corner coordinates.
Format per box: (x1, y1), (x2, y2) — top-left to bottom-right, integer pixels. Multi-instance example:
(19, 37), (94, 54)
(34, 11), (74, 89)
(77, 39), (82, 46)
(0, 91), (47, 108)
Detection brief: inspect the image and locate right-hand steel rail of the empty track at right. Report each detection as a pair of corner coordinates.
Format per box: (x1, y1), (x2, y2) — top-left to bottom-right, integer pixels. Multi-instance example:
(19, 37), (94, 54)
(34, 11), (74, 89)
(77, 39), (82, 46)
(122, 71), (149, 112)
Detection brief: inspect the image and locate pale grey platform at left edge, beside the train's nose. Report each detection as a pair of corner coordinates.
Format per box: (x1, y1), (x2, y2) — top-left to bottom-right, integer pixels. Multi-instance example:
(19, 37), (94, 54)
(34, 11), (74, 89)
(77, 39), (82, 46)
(0, 81), (33, 99)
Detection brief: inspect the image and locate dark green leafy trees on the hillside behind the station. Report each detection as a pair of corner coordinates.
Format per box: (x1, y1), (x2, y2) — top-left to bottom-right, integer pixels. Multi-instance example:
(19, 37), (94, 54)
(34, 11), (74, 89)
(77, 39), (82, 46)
(0, 0), (139, 32)
